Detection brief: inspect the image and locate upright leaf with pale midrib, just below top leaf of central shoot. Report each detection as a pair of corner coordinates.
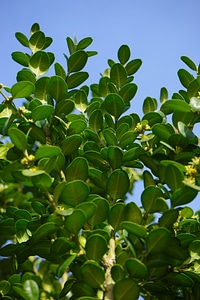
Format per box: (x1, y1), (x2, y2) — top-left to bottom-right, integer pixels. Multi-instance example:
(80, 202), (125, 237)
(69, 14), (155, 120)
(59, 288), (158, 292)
(110, 63), (127, 89)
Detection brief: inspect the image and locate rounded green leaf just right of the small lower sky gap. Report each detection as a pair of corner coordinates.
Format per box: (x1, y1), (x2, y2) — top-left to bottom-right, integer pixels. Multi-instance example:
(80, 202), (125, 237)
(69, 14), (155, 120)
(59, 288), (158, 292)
(141, 185), (163, 213)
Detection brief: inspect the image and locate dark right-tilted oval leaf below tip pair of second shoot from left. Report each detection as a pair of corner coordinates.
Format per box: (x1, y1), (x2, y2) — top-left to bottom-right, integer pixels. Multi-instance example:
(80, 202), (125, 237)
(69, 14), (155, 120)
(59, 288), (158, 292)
(67, 50), (88, 73)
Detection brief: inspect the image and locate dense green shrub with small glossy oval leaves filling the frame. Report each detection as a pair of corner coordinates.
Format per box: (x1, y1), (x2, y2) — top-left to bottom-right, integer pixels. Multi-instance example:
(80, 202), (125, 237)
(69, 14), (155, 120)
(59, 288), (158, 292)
(0, 24), (200, 300)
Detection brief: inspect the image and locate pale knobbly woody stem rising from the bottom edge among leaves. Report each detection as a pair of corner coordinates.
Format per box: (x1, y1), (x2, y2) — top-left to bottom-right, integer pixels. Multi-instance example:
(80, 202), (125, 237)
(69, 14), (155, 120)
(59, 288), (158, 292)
(103, 238), (115, 300)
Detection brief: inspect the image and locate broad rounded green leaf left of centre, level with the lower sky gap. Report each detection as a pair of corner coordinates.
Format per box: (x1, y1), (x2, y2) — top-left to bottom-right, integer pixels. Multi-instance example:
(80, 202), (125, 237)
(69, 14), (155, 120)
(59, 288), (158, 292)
(61, 180), (89, 207)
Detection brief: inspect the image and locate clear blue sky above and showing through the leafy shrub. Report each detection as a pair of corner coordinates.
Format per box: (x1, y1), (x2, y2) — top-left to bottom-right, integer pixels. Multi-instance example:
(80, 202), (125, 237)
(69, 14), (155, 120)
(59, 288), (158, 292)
(0, 0), (200, 210)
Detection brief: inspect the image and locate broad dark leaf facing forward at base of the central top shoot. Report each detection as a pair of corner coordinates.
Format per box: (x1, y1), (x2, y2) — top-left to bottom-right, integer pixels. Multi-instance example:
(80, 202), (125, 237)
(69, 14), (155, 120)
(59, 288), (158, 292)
(104, 94), (124, 119)
